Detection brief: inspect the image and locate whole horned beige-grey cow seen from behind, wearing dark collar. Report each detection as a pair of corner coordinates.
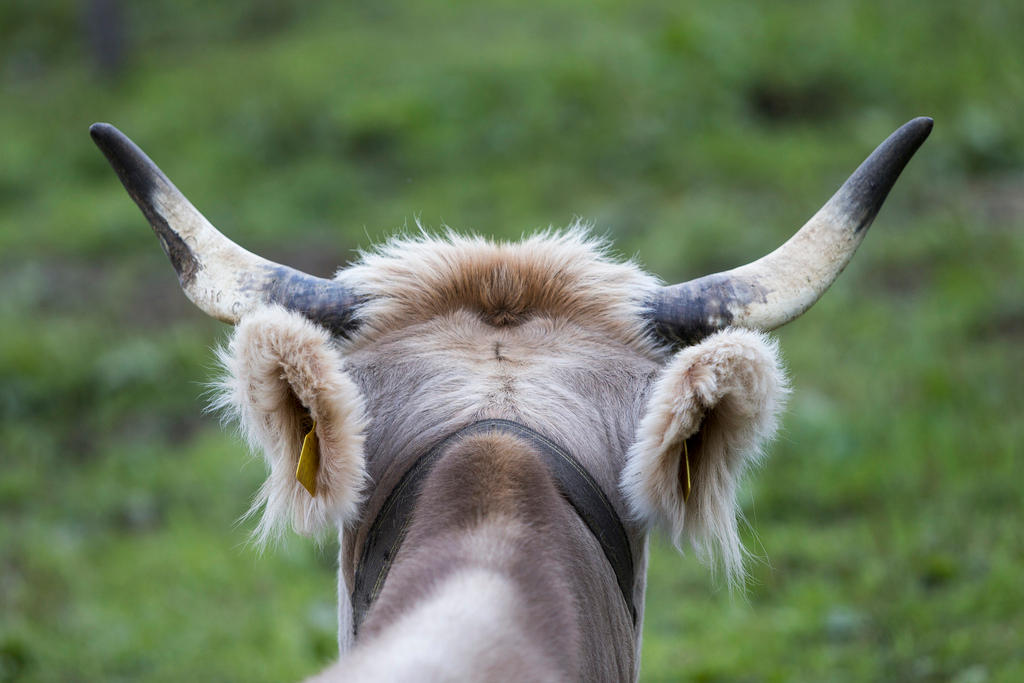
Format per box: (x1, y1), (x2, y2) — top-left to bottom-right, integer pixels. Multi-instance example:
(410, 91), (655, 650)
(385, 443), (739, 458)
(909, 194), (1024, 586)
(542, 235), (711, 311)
(91, 118), (932, 681)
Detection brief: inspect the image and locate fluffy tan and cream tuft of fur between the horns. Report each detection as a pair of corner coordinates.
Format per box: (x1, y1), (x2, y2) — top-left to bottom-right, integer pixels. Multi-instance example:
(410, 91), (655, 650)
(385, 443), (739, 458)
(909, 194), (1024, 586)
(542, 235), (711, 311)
(336, 225), (658, 353)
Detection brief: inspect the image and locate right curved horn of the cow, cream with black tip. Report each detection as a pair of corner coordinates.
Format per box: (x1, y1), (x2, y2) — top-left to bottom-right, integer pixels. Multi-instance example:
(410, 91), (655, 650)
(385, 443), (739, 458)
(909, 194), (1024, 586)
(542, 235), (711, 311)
(650, 117), (932, 344)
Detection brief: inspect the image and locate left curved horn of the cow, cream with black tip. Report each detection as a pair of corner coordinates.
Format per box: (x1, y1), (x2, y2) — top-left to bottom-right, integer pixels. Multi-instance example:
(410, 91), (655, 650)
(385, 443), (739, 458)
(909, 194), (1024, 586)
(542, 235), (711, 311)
(89, 123), (357, 334)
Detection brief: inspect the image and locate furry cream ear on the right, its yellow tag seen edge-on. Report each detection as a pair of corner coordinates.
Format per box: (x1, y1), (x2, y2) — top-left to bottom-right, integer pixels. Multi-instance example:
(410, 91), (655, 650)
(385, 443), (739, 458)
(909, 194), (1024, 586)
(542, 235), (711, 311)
(623, 329), (788, 585)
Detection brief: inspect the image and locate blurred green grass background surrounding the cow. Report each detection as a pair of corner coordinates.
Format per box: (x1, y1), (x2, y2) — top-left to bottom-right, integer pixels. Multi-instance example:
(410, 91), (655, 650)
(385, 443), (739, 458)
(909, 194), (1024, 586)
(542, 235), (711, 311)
(0, 0), (1024, 683)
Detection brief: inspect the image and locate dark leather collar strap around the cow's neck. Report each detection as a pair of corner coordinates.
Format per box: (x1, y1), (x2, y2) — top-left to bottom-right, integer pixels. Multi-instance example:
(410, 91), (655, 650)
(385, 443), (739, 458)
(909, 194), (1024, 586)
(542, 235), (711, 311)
(352, 419), (637, 632)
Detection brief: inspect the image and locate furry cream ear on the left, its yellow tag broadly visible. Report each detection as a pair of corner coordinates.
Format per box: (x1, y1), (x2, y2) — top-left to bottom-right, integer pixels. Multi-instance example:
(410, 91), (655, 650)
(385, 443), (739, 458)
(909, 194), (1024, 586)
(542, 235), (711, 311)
(214, 306), (367, 545)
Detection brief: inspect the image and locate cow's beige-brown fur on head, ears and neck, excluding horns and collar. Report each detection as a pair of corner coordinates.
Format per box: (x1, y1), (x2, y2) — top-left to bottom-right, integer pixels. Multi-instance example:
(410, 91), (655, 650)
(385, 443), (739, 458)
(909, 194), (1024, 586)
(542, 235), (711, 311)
(219, 228), (785, 681)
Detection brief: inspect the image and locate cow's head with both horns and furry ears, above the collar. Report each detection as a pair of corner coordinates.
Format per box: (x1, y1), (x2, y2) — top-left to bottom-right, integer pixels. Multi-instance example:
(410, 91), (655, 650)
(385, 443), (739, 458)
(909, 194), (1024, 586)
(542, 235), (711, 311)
(91, 118), (932, 667)
